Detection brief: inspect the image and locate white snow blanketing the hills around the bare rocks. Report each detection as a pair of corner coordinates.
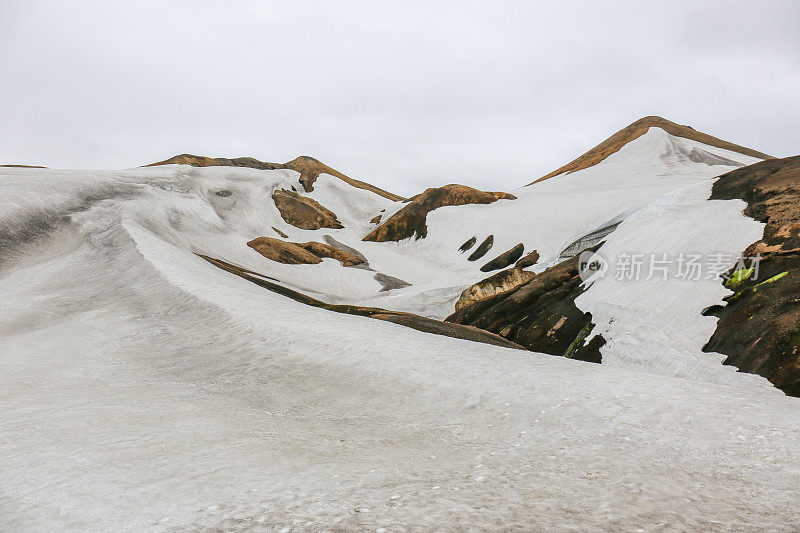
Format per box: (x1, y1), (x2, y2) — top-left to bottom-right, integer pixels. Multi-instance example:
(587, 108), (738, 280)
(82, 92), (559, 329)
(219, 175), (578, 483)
(0, 129), (800, 531)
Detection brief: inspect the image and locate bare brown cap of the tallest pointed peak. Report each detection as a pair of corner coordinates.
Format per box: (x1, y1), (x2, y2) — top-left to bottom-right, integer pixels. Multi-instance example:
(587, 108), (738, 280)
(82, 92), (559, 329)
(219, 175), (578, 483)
(528, 116), (772, 185)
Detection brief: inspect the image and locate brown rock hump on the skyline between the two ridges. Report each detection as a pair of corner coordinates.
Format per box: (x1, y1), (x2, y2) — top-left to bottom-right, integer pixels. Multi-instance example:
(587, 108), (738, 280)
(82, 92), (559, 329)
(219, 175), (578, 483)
(363, 184), (516, 242)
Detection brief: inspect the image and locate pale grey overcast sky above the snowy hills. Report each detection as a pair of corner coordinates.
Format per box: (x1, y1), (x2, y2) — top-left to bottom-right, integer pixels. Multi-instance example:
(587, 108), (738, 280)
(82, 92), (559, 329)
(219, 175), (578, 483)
(0, 0), (800, 194)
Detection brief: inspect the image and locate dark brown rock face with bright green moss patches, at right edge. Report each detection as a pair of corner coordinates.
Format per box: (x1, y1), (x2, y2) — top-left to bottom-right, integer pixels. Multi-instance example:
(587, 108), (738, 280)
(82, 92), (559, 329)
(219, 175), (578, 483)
(704, 156), (800, 396)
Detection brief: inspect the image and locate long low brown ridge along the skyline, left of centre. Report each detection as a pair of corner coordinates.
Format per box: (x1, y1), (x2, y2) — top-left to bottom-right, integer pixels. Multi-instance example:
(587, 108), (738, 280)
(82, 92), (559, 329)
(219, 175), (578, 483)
(145, 154), (405, 202)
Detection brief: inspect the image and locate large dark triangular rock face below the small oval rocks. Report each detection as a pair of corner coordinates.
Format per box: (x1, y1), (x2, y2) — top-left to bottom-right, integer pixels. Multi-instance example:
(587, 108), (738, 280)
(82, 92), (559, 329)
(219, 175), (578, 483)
(446, 252), (605, 362)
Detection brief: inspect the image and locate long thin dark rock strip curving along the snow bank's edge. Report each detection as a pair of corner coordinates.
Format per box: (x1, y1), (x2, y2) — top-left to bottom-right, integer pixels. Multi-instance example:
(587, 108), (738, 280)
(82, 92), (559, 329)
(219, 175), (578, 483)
(200, 255), (524, 350)
